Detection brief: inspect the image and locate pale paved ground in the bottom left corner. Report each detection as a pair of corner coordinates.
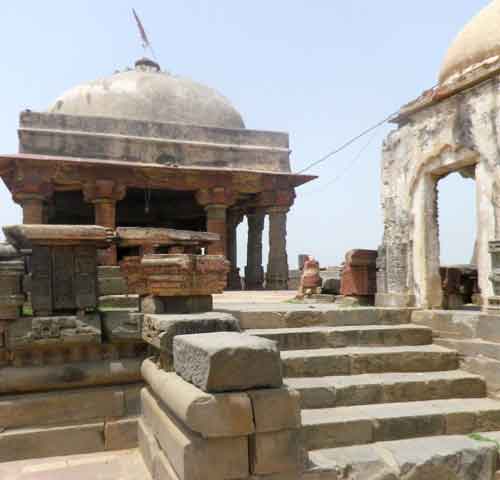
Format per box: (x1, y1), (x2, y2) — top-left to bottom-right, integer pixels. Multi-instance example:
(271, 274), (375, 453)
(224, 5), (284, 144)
(0, 449), (151, 480)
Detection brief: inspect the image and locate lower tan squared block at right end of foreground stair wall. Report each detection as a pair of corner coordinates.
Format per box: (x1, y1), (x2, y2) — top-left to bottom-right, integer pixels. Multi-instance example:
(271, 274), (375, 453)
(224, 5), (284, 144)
(250, 430), (301, 475)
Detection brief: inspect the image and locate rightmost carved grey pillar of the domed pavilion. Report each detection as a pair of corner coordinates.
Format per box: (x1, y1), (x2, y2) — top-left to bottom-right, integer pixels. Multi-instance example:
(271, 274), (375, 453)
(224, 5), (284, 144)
(266, 207), (289, 290)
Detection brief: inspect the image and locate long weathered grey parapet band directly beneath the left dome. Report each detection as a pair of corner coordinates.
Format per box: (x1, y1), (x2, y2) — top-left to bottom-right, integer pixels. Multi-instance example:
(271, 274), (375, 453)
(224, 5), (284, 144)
(19, 112), (290, 172)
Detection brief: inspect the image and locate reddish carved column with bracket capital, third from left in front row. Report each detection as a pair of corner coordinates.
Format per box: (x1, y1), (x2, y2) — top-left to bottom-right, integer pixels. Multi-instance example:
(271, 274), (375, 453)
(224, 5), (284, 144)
(196, 187), (234, 256)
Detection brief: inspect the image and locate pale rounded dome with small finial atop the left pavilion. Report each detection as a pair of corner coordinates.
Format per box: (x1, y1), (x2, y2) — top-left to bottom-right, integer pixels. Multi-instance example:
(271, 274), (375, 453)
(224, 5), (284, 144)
(48, 58), (245, 129)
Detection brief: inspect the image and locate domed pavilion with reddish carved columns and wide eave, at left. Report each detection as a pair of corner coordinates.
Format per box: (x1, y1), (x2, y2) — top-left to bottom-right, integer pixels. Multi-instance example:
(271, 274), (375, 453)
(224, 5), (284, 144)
(0, 59), (313, 289)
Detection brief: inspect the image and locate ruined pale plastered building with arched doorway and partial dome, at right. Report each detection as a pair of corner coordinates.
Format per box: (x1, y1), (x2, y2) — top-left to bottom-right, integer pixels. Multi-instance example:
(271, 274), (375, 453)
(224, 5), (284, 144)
(377, 1), (500, 308)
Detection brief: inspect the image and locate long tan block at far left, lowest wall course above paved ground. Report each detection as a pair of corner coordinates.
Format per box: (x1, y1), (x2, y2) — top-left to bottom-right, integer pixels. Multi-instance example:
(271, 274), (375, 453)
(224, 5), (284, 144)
(0, 423), (104, 462)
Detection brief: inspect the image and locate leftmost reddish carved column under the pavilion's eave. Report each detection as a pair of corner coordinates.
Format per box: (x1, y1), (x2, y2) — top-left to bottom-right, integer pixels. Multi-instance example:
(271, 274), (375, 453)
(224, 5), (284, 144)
(12, 181), (53, 225)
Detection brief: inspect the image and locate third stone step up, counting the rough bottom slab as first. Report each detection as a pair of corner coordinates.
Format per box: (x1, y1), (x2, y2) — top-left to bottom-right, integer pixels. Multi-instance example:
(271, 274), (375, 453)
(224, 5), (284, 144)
(285, 370), (486, 408)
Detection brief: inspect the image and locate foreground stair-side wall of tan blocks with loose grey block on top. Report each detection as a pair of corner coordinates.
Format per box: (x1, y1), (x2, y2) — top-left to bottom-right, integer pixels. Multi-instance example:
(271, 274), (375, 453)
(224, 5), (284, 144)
(139, 333), (303, 480)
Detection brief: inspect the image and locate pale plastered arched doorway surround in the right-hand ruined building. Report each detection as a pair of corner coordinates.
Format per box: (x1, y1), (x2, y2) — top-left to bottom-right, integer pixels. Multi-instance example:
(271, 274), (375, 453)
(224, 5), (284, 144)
(409, 146), (484, 308)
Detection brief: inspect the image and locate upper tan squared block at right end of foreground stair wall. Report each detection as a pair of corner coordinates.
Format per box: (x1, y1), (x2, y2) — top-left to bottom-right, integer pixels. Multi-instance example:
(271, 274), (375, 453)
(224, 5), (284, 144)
(248, 388), (301, 432)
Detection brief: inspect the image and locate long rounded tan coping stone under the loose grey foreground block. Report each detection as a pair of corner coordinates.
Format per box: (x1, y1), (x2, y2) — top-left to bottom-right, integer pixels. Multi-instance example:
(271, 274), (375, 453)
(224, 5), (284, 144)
(141, 360), (254, 438)
